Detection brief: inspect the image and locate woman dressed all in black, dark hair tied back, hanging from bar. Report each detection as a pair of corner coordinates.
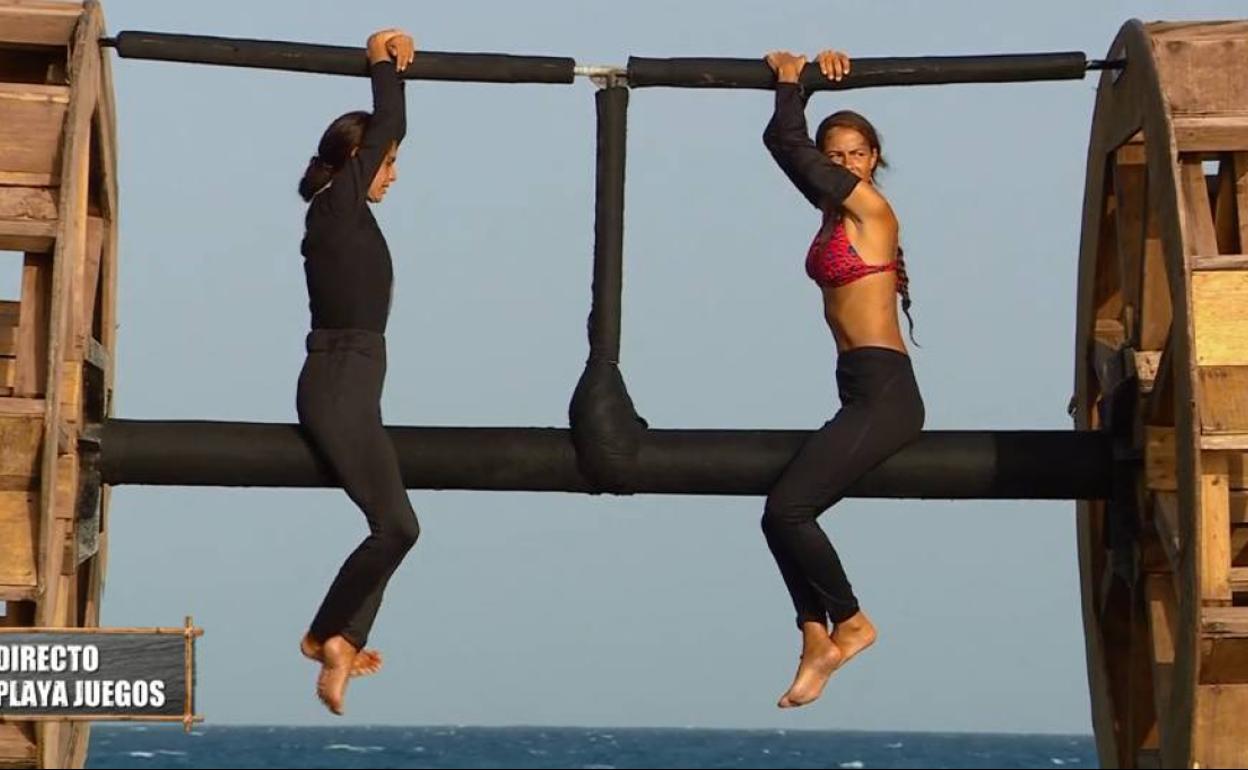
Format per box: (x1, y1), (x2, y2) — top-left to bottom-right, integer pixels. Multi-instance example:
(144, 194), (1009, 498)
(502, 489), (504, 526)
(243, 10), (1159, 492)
(297, 29), (421, 714)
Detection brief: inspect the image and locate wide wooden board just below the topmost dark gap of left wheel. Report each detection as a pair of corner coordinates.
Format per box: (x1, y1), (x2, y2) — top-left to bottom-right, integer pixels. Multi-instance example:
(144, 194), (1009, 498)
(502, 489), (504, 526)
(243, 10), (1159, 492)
(0, 82), (70, 176)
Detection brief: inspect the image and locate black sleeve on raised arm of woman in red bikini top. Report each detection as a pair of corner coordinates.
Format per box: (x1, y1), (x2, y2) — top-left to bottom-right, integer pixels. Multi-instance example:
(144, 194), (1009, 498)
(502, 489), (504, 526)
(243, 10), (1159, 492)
(763, 82), (861, 212)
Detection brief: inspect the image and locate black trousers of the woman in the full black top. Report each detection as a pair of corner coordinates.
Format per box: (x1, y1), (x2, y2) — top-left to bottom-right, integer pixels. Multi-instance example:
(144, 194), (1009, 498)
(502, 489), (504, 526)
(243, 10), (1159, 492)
(297, 329), (421, 648)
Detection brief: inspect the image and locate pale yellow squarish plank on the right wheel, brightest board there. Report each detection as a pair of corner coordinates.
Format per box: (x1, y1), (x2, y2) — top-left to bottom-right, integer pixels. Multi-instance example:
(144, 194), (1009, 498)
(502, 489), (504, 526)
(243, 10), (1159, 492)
(1192, 270), (1248, 366)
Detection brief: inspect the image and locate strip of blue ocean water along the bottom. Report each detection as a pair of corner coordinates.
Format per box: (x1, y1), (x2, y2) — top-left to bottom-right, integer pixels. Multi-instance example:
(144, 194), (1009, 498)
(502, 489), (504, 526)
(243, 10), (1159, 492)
(86, 725), (1097, 770)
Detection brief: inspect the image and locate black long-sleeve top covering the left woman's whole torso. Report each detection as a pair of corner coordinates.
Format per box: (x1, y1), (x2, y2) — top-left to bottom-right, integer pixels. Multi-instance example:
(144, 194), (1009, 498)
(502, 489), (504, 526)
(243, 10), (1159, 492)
(300, 61), (407, 333)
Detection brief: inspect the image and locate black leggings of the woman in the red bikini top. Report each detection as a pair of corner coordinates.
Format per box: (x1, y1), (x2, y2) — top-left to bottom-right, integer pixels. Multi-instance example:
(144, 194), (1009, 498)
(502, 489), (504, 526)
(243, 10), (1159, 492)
(763, 347), (924, 626)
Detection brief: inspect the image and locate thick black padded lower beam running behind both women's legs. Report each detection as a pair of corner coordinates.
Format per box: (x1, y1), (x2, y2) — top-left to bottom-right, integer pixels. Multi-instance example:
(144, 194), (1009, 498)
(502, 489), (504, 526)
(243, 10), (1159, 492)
(100, 419), (1113, 499)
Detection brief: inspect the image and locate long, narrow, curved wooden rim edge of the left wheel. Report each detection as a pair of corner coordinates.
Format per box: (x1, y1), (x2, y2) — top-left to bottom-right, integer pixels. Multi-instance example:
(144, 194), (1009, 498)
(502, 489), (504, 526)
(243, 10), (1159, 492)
(35, 0), (101, 623)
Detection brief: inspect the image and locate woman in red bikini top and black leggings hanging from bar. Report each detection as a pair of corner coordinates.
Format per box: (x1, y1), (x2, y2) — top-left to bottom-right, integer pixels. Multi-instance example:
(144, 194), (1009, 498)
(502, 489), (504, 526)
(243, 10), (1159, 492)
(763, 51), (924, 708)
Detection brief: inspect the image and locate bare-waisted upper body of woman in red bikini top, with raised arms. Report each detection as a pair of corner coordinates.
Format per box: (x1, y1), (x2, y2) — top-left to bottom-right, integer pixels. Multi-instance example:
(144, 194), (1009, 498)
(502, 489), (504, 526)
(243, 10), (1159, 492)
(764, 51), (914, 352)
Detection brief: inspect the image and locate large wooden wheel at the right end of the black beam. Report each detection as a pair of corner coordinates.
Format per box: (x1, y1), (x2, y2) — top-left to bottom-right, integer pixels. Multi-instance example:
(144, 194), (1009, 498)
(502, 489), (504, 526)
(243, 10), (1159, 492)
(1072, 21), (1248, 768)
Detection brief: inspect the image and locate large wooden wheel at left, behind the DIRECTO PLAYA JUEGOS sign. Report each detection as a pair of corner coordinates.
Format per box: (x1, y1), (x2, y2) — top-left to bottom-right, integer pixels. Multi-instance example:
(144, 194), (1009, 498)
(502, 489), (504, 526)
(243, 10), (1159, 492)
(0, 0), (117, 768)
